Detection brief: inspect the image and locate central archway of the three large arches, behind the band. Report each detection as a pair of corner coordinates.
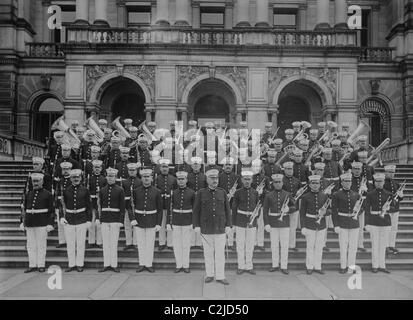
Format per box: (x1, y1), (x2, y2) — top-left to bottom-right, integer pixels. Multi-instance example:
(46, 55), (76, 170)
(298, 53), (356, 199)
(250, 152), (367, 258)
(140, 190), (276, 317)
(188, 79), (235, 127)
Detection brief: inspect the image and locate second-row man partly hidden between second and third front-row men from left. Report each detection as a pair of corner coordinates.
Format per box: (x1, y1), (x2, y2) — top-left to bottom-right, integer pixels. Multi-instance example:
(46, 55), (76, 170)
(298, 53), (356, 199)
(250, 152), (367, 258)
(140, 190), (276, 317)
(86, 160), (107, 249)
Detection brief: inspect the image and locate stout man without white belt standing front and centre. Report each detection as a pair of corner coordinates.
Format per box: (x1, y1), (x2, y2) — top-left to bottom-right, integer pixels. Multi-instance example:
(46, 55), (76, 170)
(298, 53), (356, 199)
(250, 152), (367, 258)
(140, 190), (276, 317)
(193, 169), (232, 285)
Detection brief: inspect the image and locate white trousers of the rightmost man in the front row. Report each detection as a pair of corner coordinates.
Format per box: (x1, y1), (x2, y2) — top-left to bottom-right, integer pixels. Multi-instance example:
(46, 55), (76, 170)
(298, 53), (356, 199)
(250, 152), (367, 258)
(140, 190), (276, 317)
(370, 226), (391, 269)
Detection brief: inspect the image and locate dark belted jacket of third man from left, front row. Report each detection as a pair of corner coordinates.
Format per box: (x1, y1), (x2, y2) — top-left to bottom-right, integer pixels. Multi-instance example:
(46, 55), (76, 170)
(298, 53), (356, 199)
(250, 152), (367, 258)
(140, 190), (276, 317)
(97, 184), (125, 224)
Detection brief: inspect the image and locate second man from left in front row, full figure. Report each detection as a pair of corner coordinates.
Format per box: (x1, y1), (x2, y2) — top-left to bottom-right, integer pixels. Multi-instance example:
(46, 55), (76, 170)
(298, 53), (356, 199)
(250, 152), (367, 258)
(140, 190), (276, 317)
(60, 169), (92, 272)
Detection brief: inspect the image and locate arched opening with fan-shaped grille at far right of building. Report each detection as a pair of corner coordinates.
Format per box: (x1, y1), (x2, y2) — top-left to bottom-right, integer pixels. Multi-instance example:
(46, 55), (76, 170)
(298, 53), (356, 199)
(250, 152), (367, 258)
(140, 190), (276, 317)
(360, 99), (390, 147)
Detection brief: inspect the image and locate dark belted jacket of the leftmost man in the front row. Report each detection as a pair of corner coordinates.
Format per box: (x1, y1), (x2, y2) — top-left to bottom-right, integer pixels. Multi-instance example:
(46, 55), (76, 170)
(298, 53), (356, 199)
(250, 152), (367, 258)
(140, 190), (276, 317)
(22, 188), (54, 228)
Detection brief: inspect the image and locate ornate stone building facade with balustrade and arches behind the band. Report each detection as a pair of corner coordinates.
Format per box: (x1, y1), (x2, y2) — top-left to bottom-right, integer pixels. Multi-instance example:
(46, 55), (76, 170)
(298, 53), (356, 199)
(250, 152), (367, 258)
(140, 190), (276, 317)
(0, 0), (413, 163)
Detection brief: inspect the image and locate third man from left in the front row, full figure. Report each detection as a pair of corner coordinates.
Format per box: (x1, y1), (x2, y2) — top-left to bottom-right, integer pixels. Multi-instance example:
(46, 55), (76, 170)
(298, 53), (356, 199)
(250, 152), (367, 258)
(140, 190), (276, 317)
(96, 168), (125, 272)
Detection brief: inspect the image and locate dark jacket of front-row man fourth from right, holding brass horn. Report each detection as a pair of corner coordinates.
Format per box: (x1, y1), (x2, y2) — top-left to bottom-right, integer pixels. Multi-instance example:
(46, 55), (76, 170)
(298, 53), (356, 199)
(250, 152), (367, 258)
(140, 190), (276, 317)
(263, 189), (296, 228)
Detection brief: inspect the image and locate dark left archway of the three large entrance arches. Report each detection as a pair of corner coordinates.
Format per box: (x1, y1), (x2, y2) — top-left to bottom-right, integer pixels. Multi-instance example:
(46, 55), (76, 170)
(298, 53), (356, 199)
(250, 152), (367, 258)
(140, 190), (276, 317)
(100, 77), (146, 125)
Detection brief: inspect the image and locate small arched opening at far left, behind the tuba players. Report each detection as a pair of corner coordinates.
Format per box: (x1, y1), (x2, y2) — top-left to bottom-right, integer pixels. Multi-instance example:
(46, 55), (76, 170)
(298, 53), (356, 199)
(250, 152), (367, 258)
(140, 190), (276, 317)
(31, 95), (64, 143)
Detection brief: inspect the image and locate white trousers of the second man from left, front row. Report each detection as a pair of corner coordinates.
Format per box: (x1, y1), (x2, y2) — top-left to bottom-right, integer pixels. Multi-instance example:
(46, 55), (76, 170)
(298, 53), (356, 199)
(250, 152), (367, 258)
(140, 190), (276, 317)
(65, 223), (87, 268)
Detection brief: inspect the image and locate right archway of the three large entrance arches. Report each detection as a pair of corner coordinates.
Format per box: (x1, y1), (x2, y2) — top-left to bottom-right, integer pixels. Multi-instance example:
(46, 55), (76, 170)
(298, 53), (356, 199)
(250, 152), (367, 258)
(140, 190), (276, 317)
(277, 80), (322, 139)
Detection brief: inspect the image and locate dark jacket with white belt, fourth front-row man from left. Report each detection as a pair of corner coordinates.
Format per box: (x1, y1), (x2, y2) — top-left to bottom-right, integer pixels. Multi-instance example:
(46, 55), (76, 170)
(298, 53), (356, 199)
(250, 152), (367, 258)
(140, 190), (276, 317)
(129, 185), (162, 228)
